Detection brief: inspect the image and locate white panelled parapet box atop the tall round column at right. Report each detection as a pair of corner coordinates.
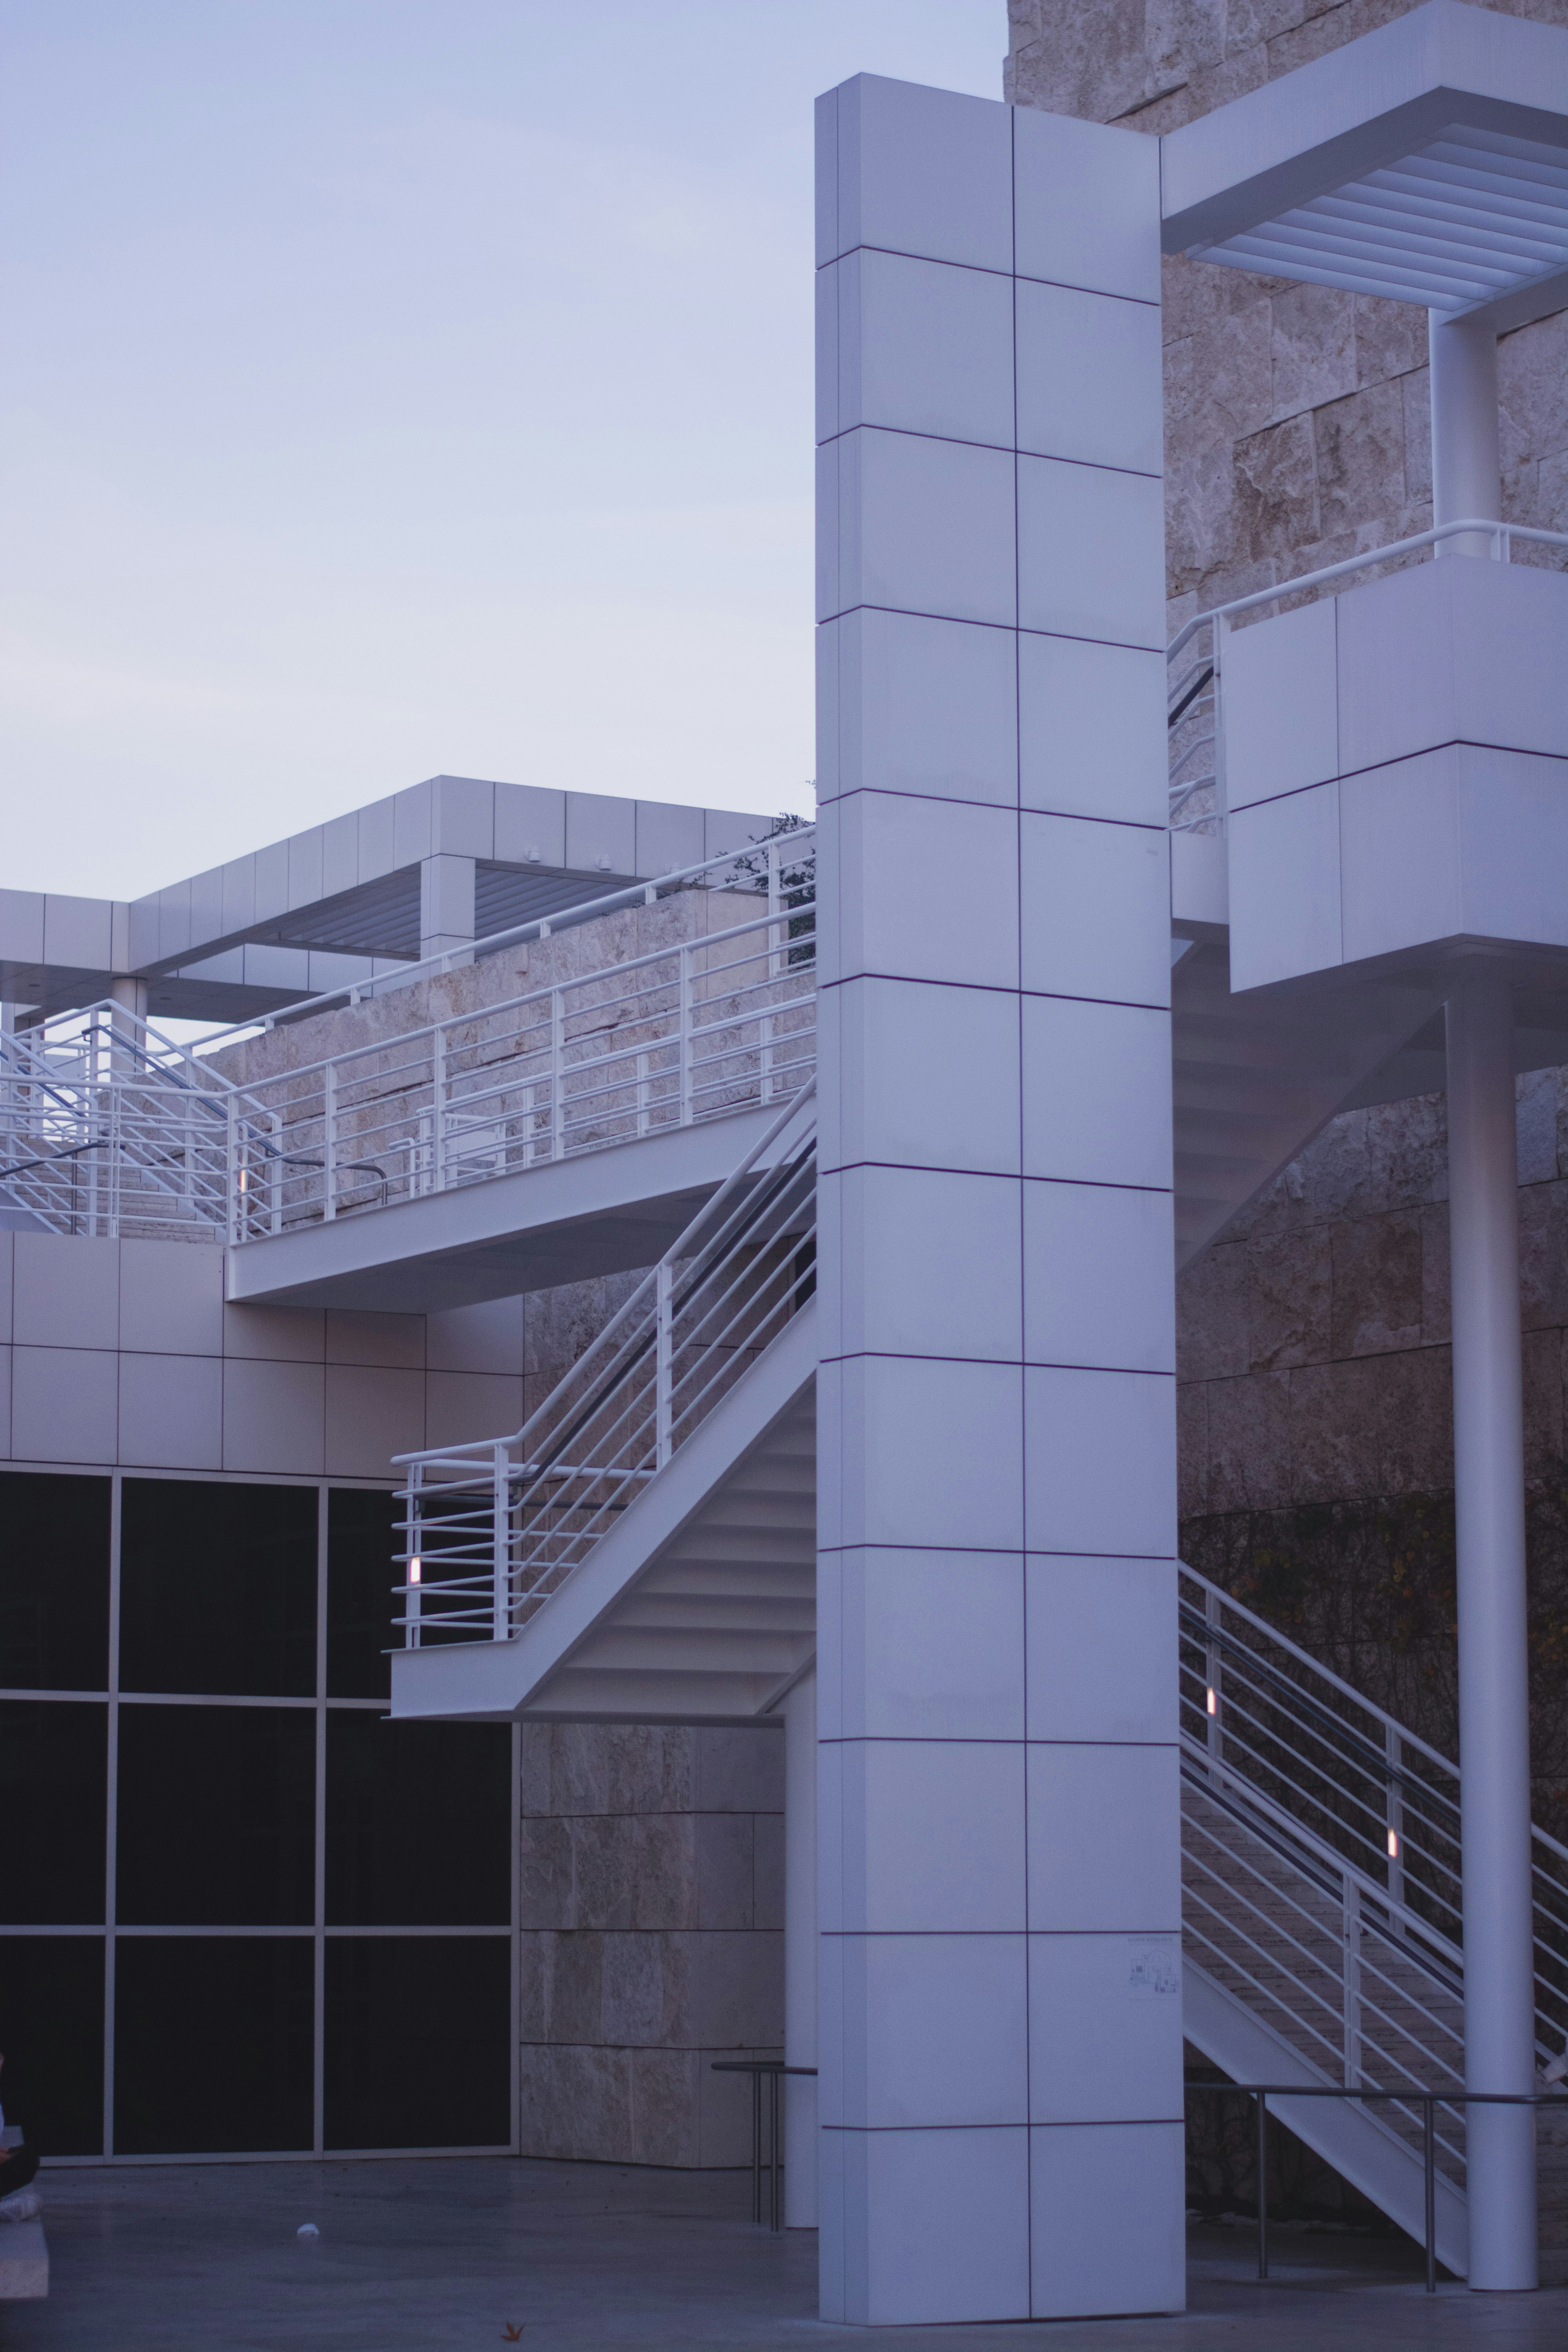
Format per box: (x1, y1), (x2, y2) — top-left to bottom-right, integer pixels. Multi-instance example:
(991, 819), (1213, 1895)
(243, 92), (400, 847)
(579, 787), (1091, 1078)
(1222, 557), (1568, 988)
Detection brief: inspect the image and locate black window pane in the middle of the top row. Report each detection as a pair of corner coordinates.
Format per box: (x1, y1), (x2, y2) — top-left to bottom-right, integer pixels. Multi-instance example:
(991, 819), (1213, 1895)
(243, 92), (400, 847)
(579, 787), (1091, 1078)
(120, 1477), (318, 1698)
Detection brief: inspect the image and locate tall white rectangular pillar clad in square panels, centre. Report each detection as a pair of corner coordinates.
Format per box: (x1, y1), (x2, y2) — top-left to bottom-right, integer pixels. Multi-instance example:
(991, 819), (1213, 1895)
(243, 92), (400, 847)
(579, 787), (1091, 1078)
(818, 78), (1185, 2324)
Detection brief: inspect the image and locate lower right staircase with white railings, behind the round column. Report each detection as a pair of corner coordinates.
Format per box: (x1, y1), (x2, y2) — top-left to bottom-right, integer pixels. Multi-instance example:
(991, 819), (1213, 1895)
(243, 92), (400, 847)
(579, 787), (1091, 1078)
(1180, 1569), (1568, 2274)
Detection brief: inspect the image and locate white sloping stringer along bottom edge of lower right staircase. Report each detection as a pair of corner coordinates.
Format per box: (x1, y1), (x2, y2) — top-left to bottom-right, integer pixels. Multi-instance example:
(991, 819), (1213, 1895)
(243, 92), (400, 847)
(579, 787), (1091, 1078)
(1182, 1957), (1469, 2277)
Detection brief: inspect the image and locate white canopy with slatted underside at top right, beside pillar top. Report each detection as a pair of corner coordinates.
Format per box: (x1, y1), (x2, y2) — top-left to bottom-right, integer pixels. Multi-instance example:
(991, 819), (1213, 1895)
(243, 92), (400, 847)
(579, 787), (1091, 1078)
(1161, 0), (1568, 329)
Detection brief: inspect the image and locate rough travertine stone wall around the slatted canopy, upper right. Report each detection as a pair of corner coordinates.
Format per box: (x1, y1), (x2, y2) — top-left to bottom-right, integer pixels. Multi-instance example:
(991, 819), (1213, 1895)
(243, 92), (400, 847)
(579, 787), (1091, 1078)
(1004, 0), (1568, 621)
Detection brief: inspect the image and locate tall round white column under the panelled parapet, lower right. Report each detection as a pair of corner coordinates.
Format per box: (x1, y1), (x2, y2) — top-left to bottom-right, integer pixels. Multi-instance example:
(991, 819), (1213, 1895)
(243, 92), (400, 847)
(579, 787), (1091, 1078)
(1443, 964), (1535, 2288)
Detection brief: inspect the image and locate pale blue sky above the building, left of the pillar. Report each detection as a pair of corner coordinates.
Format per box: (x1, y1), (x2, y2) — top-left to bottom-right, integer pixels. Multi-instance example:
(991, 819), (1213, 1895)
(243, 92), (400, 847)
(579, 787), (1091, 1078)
(0, 0), (1006, 896)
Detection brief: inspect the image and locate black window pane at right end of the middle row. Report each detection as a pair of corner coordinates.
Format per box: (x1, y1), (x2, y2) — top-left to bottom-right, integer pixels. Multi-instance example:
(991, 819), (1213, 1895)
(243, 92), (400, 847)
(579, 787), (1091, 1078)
(327, 1712), (512, 1926)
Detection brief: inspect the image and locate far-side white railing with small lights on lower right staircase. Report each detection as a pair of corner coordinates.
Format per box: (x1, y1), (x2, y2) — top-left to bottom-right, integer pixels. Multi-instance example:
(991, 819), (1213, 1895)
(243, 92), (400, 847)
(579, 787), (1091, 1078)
(1180, 1566), (1568, 2058)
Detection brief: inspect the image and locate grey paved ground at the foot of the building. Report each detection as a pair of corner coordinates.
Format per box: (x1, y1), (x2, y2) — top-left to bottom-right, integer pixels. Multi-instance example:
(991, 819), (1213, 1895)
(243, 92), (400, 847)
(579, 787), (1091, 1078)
(0, 2157), (1568, 2352)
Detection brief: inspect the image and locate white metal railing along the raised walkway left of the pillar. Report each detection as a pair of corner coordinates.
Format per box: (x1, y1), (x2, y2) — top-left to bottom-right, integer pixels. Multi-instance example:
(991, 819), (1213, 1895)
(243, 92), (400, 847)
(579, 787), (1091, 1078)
(228, 835), (816, 1244)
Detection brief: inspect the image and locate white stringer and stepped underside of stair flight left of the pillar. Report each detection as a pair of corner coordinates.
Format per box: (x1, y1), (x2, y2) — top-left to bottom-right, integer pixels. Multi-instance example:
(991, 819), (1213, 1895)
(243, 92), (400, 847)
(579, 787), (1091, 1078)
(392, 1301), (818, 1724)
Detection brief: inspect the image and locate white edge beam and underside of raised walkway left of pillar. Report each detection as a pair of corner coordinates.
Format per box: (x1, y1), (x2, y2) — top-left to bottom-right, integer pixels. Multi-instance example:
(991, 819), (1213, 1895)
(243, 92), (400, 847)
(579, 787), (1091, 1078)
(228, 1105), (776, 1315)
